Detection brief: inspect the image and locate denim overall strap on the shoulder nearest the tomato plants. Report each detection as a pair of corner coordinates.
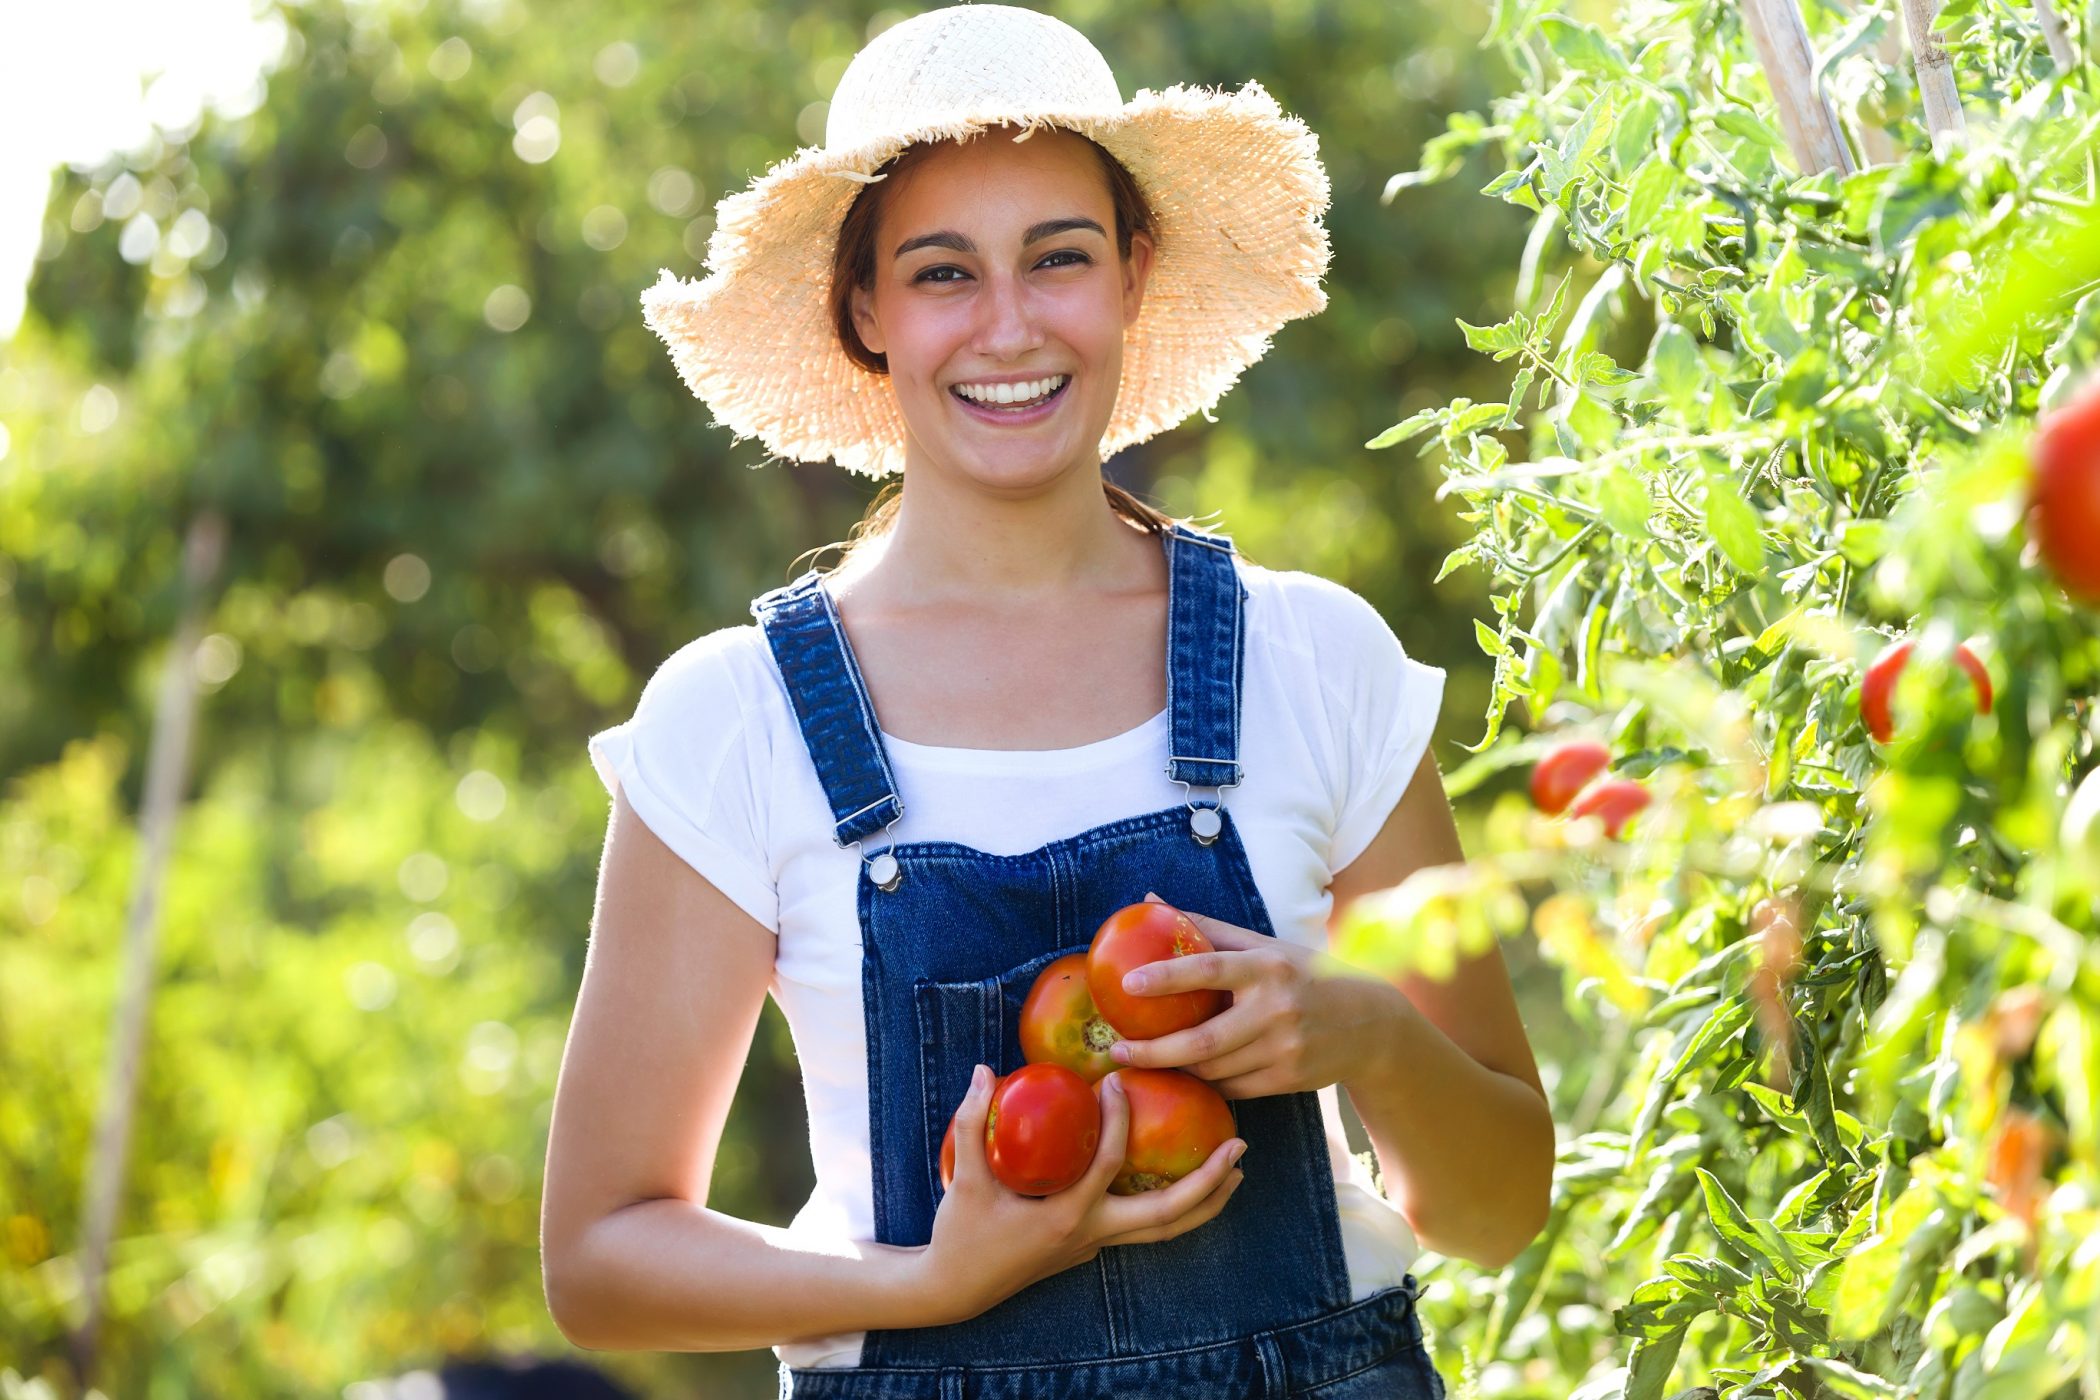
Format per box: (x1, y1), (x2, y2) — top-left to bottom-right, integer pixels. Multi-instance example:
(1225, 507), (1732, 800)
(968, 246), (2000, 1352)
(1166, 523), (1247, 787)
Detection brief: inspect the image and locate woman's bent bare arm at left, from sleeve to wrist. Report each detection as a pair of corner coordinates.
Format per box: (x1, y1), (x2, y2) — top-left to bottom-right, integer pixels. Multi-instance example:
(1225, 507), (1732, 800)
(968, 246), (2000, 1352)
(540, 793), (949, 1352)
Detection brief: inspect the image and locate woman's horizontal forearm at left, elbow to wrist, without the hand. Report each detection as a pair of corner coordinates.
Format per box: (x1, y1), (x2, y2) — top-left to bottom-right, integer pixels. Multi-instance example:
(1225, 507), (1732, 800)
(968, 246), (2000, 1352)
(546, 1199), (956, 1352)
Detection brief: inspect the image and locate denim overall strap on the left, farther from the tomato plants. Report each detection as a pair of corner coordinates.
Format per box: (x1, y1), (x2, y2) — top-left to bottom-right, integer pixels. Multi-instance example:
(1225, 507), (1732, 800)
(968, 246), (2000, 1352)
(752, 569), (905, 846)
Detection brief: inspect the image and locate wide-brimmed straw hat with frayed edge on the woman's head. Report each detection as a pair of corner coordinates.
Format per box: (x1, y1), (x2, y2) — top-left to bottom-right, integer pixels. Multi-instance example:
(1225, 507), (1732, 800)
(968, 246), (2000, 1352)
(643, 4), (1327, 476)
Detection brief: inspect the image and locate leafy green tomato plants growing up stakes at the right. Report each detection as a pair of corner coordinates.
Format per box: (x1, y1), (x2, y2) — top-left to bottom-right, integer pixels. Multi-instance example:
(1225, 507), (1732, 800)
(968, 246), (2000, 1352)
(1350, 0), (2100, 1400)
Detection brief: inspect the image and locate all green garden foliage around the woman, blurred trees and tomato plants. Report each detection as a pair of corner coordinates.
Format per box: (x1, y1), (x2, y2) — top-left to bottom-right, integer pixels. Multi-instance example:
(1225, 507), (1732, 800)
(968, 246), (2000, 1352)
(0, 0), (2100, 1400)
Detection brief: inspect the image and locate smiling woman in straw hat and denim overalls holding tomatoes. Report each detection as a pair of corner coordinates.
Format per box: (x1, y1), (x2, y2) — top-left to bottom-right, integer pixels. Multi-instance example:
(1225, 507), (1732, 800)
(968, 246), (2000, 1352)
(542, 6), (1554, 1400)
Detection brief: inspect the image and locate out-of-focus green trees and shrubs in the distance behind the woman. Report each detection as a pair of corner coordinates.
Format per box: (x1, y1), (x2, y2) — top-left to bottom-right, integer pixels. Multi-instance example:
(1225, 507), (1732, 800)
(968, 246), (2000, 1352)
(0, 0), (1552, 1396)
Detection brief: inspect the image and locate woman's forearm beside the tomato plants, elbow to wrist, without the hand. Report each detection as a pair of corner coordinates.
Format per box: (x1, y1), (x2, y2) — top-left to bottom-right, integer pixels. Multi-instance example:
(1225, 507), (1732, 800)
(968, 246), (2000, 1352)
(1342, 980), (1554, 1268)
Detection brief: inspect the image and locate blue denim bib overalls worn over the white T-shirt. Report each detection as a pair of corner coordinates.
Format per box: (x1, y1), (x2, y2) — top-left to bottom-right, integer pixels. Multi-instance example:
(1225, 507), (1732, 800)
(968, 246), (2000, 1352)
(752, 525), (1445, 1400)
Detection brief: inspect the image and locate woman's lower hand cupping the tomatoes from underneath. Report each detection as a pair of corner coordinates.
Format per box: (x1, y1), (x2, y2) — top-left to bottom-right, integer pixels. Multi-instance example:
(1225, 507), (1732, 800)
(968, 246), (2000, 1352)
(922, 1064), (1245, 1322)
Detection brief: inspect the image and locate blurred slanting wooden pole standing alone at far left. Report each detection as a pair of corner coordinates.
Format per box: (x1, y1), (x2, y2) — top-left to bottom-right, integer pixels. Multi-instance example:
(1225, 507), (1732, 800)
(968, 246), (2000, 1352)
(71, 510), (227, 1392)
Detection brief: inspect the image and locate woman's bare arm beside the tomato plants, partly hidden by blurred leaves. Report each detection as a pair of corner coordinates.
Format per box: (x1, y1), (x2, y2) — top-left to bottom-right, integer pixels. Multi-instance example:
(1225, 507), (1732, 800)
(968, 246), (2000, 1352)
(1329, 751), (1556, 1268)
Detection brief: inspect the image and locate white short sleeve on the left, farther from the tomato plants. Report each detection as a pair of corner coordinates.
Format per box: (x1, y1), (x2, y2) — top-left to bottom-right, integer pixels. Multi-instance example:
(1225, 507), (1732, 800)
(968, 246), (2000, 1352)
(586, 628), (779, 932)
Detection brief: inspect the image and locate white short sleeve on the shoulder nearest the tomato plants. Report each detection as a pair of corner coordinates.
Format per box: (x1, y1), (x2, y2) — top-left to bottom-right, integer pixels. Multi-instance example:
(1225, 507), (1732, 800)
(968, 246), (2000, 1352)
(1317, 584), (1445, 871)
